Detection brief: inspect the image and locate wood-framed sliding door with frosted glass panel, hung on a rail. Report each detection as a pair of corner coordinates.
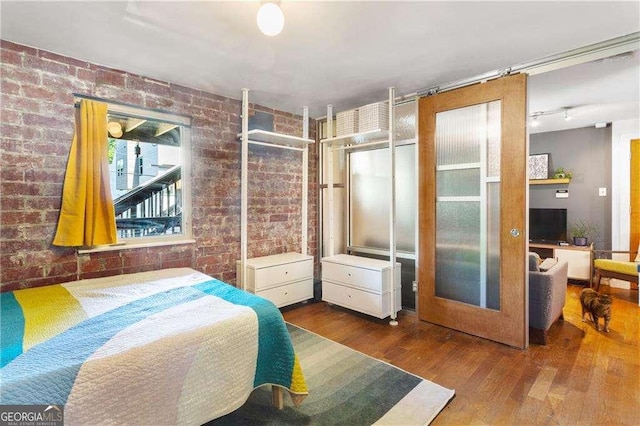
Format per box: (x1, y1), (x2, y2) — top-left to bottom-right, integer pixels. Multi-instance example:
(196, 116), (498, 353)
(418, 75), (528, 348)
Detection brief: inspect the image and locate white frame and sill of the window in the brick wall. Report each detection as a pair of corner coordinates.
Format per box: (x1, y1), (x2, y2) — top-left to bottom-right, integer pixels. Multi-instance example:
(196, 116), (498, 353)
(75, 95), (195, 254)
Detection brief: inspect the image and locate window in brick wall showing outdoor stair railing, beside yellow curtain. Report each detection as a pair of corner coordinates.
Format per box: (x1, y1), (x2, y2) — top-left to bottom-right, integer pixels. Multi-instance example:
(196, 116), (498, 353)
(95, 101), (191, 244)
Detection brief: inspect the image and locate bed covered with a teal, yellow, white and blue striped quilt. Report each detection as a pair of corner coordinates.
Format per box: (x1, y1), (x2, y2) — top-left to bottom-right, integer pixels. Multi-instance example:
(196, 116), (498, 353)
(0, 268), (307, 425)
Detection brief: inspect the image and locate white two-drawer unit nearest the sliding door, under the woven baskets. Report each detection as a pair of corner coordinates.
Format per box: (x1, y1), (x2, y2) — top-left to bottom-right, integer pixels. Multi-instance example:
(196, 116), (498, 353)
(322, 254), (401, 318)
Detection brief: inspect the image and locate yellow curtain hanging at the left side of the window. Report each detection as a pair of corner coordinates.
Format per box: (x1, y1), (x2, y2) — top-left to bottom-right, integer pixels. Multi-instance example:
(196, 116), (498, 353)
(53, 100), (117, 247)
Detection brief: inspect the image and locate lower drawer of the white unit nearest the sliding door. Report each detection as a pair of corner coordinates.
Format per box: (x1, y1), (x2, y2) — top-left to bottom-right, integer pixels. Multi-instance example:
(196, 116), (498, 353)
(322, 281), (400, 318)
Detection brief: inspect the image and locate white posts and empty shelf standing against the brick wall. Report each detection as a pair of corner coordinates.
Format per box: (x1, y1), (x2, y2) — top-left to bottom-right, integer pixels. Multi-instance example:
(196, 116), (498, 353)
(238, 89), (315, 306)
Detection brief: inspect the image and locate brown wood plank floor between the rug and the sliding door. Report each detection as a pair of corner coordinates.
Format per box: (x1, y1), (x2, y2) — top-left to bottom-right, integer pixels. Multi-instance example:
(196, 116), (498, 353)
(283, 284), (640, 425)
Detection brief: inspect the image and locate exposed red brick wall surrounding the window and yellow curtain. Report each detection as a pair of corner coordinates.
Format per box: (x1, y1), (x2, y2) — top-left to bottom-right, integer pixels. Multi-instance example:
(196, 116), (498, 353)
(0, 40), (318, 291)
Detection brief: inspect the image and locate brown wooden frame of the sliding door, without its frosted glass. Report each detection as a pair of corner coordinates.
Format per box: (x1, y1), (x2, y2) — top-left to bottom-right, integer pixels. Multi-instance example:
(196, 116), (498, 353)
(418, 74), (529, 348)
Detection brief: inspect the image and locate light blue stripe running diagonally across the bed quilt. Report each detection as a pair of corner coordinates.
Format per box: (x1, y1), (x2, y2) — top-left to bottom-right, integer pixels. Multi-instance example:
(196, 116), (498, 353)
(0, 280), (291, 405)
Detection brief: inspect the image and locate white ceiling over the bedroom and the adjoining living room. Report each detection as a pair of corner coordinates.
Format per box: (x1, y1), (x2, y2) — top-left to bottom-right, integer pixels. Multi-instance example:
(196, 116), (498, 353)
(0, 0), (640, 131)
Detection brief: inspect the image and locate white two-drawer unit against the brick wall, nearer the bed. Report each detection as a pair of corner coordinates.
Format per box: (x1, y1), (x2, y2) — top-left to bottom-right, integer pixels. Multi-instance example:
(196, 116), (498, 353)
(236, 253), (313, 308)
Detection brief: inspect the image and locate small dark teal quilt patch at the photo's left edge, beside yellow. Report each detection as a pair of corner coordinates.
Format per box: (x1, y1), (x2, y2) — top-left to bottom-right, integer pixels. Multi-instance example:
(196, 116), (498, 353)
(0, 293), (24, 368)
